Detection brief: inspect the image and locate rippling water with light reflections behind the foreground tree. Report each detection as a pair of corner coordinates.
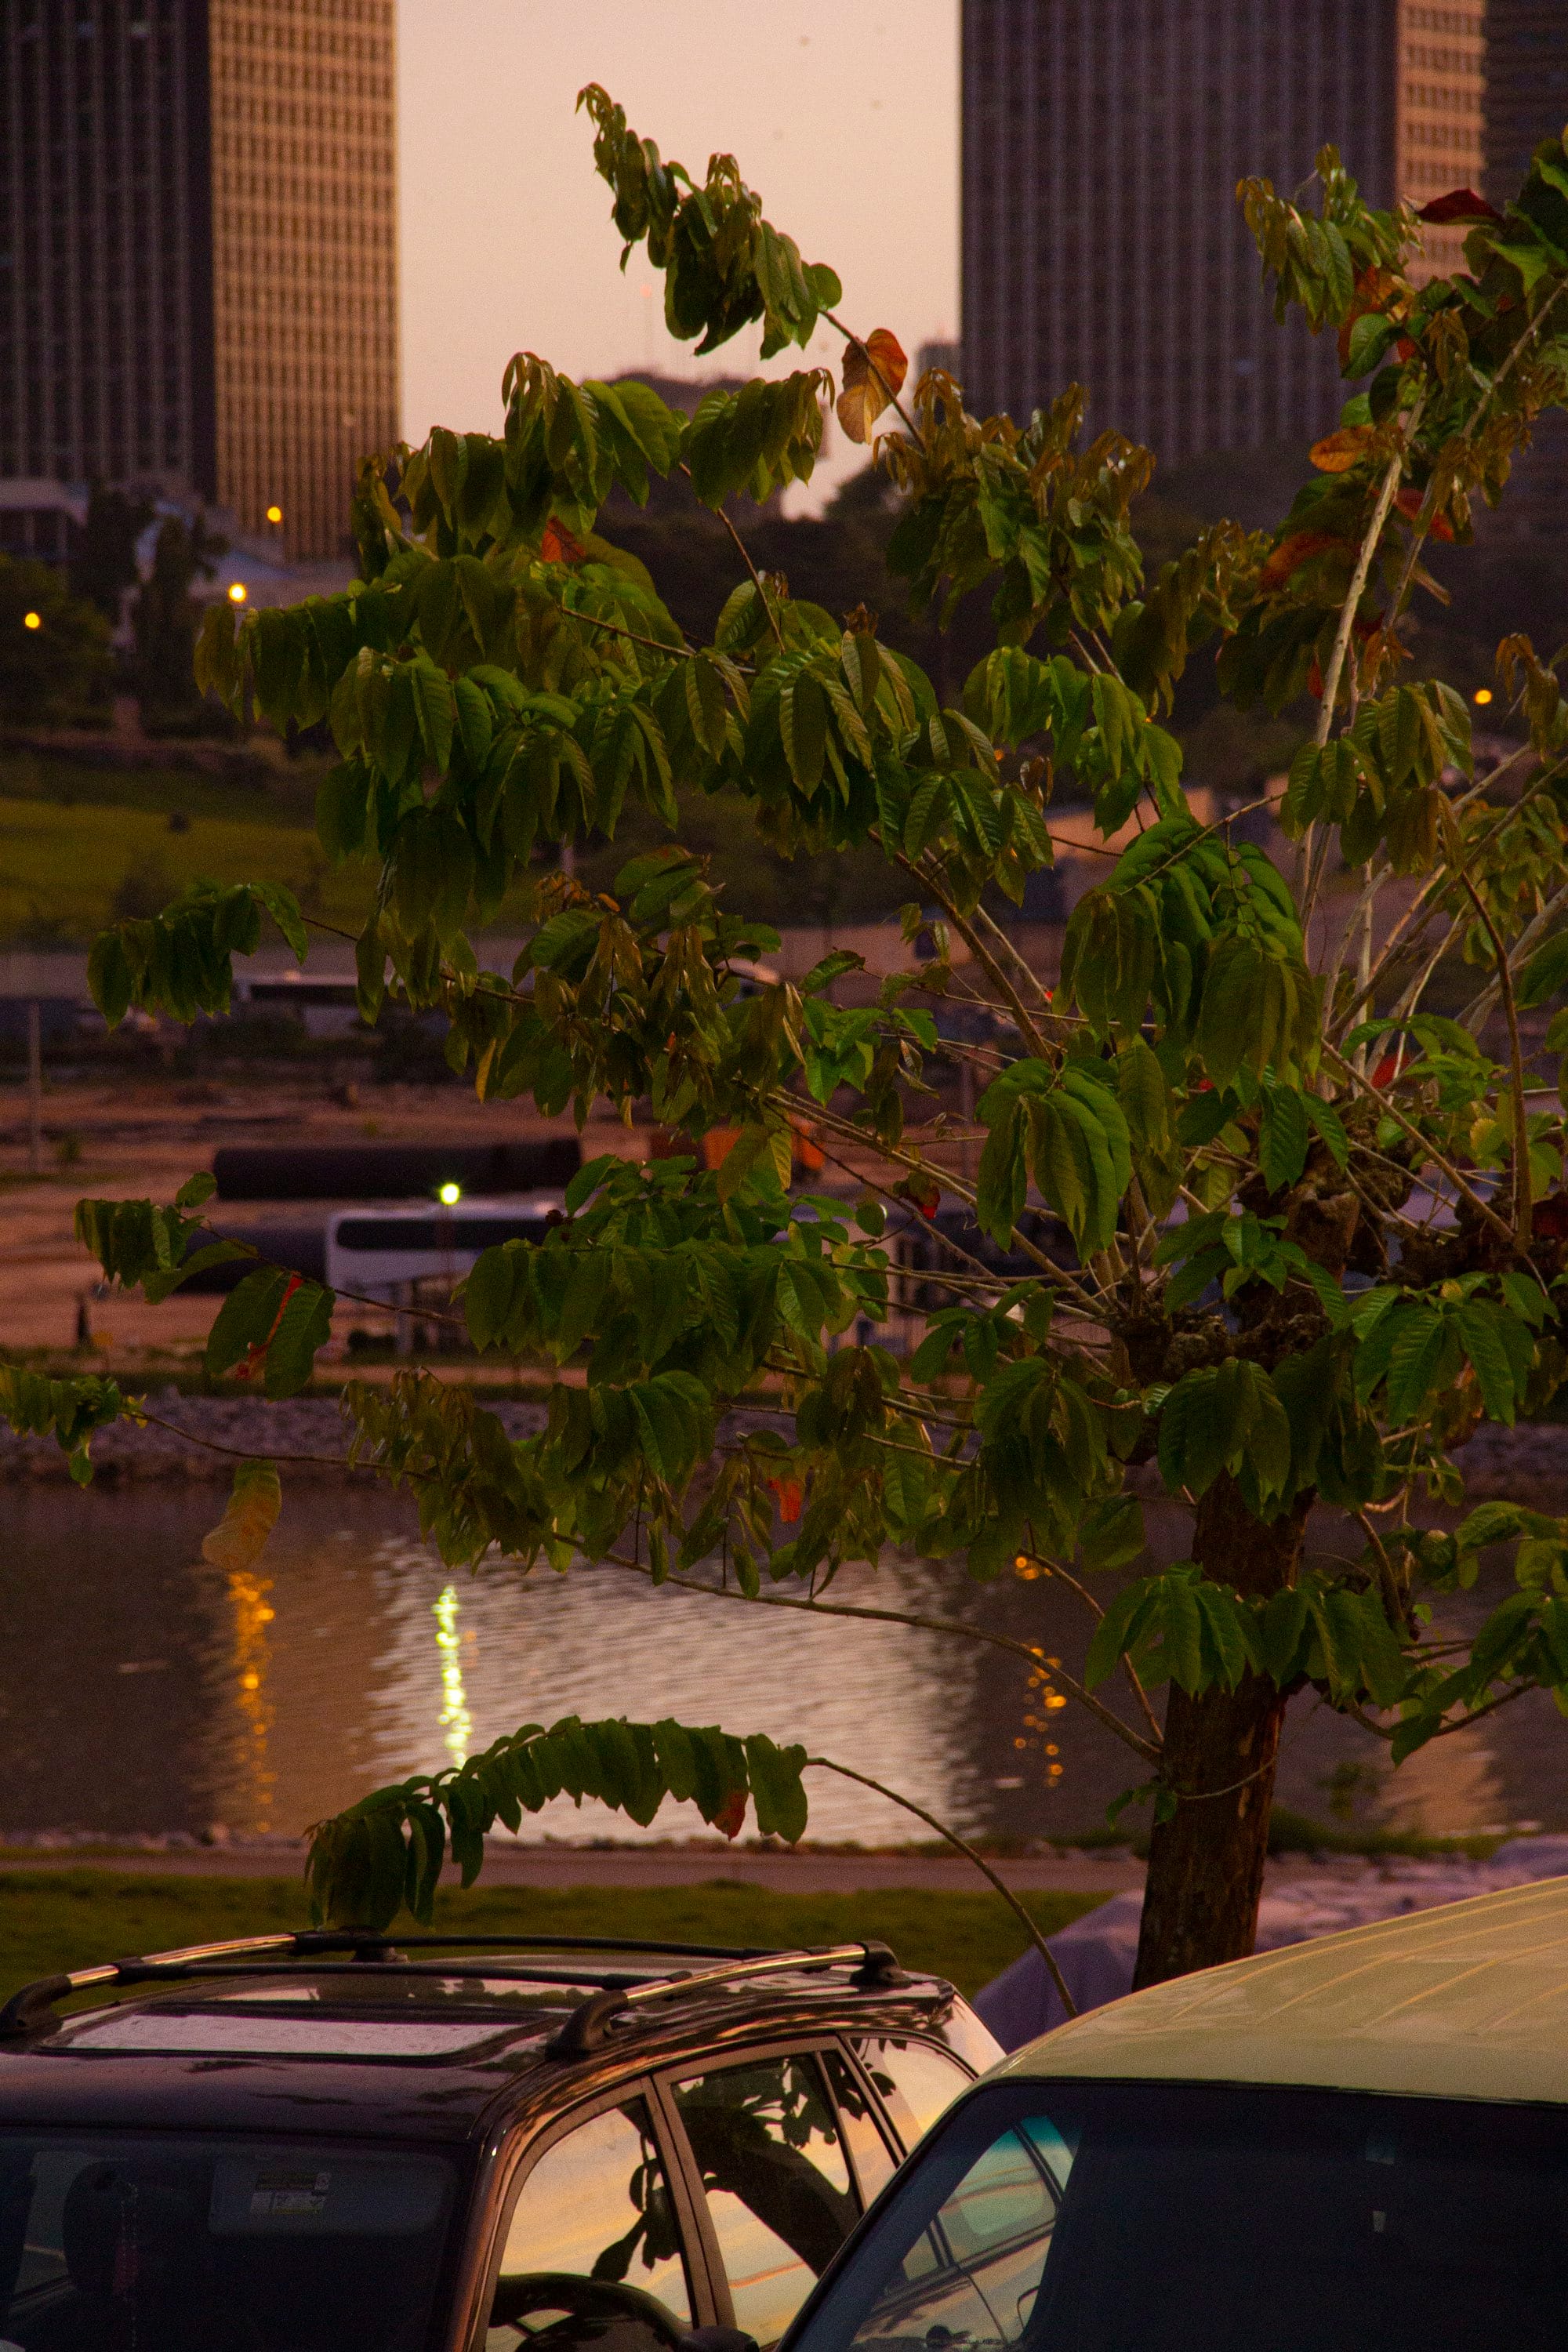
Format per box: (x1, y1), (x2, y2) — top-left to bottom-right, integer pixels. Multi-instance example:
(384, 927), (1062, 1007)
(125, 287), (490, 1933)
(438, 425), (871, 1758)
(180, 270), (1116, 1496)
(0, 1484), (1568, 1844)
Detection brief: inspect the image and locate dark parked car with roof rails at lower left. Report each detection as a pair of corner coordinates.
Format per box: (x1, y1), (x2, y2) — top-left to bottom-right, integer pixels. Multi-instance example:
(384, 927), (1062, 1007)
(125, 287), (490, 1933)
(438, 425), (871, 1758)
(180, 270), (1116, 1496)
(0, 1933), (999, 2352)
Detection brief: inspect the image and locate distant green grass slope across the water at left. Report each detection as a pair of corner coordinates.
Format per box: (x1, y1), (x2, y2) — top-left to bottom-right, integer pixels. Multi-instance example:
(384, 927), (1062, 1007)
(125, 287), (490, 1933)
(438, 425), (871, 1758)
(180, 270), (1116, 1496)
(0, 795), (374, 941)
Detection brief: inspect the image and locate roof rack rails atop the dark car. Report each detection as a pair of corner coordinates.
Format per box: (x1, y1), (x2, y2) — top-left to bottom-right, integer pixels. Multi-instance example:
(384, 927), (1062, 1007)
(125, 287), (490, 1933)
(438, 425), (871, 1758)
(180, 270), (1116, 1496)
(0, 1929), (902, 2056)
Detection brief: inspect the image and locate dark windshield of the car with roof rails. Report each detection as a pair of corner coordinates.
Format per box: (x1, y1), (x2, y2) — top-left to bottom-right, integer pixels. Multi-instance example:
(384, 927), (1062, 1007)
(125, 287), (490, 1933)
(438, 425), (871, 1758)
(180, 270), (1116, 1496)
(0, 2131), (454, 2352)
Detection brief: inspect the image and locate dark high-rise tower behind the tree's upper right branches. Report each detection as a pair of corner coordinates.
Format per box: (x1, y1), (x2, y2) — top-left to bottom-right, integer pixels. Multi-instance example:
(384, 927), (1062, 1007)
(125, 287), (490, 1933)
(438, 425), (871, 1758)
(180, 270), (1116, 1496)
(964, 0), (1481, 463)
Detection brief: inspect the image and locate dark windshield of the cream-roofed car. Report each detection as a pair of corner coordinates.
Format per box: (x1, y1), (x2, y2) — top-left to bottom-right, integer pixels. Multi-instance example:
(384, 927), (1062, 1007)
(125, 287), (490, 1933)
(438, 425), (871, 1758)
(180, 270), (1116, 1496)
(787, 2082), (1568, 2352)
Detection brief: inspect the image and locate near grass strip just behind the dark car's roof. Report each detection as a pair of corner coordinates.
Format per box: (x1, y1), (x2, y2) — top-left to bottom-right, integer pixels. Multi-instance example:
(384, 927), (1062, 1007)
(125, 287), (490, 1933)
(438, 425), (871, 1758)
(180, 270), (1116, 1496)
(0, 1867), (1105, 1999)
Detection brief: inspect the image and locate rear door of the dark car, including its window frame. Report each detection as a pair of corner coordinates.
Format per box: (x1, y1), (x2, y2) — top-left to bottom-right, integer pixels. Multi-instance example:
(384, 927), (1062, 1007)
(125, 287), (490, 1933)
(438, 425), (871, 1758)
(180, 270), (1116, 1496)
(661, 2042), (893, 2352)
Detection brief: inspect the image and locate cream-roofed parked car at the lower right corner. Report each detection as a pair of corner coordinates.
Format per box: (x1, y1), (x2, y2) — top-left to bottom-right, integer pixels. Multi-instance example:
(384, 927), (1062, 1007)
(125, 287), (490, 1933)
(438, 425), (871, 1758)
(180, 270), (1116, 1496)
(785, 1879), (1568, 2352)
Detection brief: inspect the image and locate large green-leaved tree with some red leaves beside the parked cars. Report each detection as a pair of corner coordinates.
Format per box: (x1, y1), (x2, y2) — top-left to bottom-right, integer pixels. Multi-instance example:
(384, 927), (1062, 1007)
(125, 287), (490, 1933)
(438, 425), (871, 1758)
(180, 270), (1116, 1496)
(9, 106), (1568, 1980)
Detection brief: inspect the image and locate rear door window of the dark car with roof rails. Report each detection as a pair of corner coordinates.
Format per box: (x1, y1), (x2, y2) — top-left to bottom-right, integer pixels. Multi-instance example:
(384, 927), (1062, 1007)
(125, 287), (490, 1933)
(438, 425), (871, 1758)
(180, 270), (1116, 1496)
(675, 2056), (858, 2352)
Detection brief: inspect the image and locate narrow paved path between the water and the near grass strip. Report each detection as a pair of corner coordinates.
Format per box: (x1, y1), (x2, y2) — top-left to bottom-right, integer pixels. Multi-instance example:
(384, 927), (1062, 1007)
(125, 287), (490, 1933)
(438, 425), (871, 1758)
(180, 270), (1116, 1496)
(0, 1842), (1142, 1896)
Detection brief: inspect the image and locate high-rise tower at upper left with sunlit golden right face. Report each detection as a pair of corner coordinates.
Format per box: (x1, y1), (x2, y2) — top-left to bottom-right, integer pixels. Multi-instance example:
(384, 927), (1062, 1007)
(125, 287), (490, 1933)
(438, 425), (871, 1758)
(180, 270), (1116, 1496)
(0, 0), (397, 557)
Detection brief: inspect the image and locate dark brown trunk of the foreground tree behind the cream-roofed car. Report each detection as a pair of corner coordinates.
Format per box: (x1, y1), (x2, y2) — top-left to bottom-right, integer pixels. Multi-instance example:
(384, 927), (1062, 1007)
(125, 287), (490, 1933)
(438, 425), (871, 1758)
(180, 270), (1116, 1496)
(1133, 1477), (1307, 1987)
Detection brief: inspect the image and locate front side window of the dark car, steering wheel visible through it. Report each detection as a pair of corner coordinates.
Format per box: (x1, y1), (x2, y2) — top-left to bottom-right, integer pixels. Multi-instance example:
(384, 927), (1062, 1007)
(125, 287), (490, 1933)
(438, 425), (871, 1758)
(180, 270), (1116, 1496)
(485, 2098), (691, 2352)
